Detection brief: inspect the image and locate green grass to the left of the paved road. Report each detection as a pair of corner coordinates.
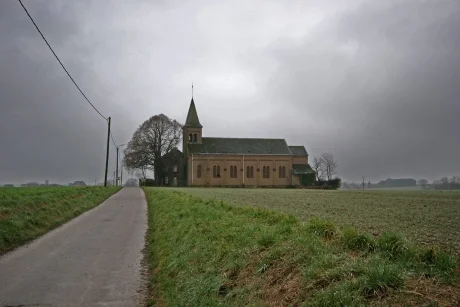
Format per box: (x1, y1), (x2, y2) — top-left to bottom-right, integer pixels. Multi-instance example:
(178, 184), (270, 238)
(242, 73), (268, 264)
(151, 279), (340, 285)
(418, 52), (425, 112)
(0, 187), (120, 254)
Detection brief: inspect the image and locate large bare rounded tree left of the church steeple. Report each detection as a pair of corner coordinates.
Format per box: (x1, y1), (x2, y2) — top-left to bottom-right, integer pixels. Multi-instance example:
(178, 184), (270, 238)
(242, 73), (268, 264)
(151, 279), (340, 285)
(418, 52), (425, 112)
(123, 114), (182, 184)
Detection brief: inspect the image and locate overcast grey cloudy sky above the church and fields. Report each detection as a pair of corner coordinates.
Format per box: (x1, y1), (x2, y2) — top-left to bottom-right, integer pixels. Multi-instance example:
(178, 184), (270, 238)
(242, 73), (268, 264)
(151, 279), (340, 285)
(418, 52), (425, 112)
(0, 0), (460, 184)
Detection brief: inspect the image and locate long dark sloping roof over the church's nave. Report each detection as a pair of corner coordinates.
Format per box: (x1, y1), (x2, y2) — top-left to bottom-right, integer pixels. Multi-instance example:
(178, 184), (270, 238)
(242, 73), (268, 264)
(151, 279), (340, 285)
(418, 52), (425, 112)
(188, 137), (291, 155)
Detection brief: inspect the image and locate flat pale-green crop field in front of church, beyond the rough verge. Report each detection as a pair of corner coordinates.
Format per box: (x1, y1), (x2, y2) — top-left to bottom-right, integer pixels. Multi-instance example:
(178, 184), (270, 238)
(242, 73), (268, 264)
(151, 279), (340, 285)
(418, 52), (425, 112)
(177, 188), (460, 252)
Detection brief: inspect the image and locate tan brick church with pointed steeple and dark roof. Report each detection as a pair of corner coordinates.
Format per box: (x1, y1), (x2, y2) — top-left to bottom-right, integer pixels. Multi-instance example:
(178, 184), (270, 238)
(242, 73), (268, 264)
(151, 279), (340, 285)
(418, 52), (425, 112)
(175, 97), (315, 187)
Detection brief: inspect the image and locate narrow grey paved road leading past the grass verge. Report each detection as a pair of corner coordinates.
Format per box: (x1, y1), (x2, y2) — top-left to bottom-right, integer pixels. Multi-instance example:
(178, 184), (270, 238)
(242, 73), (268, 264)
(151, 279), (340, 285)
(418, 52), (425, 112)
(0, 188), (147, 306)
